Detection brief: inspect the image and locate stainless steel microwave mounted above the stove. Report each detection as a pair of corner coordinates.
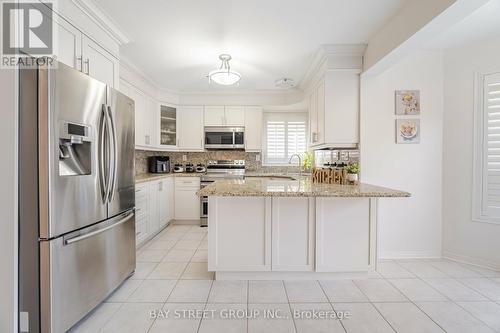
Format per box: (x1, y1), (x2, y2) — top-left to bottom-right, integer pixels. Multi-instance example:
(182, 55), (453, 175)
(205, 126), (245, 149)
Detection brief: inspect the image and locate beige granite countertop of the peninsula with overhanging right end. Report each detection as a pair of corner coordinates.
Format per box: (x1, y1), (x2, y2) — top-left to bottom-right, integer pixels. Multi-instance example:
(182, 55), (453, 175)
(197, 174), (411, 198)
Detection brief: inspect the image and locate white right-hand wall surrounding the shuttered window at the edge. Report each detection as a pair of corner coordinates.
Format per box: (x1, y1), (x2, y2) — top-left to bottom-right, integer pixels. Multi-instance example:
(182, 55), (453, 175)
(443, 37), (500, 269)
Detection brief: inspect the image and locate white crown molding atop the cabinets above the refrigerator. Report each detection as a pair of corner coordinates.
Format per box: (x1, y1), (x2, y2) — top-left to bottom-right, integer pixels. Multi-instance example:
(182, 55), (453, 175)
(71, 0), (131, 45)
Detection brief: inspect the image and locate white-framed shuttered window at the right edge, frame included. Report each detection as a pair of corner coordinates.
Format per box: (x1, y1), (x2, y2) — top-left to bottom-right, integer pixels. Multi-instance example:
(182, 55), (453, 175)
(473, 73), (500, 223)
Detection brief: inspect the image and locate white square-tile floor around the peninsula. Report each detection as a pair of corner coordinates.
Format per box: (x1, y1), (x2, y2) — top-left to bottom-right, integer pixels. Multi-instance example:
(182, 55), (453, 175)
(68, 225), (500, 333)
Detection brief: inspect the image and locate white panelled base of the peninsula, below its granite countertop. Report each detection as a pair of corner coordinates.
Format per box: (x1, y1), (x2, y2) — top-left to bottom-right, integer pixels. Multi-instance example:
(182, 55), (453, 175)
(208, 197), (373, 273)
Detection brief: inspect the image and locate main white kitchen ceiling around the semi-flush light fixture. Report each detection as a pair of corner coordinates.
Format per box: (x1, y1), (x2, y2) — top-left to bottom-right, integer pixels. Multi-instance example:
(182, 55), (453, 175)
(94, 0), (407, 92)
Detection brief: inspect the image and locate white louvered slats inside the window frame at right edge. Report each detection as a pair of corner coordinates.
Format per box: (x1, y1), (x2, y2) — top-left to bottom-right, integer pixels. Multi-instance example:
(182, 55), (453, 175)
(481, 73), (500, 218)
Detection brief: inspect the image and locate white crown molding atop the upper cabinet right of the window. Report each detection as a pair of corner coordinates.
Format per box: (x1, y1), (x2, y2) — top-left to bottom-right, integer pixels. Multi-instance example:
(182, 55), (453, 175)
(298, 44), (366, 91)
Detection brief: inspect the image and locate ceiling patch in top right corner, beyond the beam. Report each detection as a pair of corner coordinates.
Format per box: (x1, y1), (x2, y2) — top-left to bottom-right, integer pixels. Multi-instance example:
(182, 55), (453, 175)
(428, 0), (500, 49)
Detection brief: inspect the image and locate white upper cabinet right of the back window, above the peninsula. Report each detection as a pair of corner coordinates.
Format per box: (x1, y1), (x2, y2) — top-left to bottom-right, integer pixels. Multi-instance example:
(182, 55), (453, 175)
(309, 71), (359, 149)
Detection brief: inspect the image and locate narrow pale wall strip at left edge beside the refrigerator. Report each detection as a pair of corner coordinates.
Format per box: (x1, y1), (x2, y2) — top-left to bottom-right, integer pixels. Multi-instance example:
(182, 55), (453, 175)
(0, 69), (17, 332)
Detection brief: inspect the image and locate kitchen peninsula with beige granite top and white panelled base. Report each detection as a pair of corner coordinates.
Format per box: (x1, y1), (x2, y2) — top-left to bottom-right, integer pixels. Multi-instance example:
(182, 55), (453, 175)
(198, 176), (410, 280)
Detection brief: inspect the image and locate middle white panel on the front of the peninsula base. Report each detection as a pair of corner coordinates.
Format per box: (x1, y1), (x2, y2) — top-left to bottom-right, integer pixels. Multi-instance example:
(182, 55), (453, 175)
(271, 198), (315, 271)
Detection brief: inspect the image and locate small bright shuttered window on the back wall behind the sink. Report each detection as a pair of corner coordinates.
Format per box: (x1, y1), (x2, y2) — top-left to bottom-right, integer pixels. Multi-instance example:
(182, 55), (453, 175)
(263, 112), (307, 165)
